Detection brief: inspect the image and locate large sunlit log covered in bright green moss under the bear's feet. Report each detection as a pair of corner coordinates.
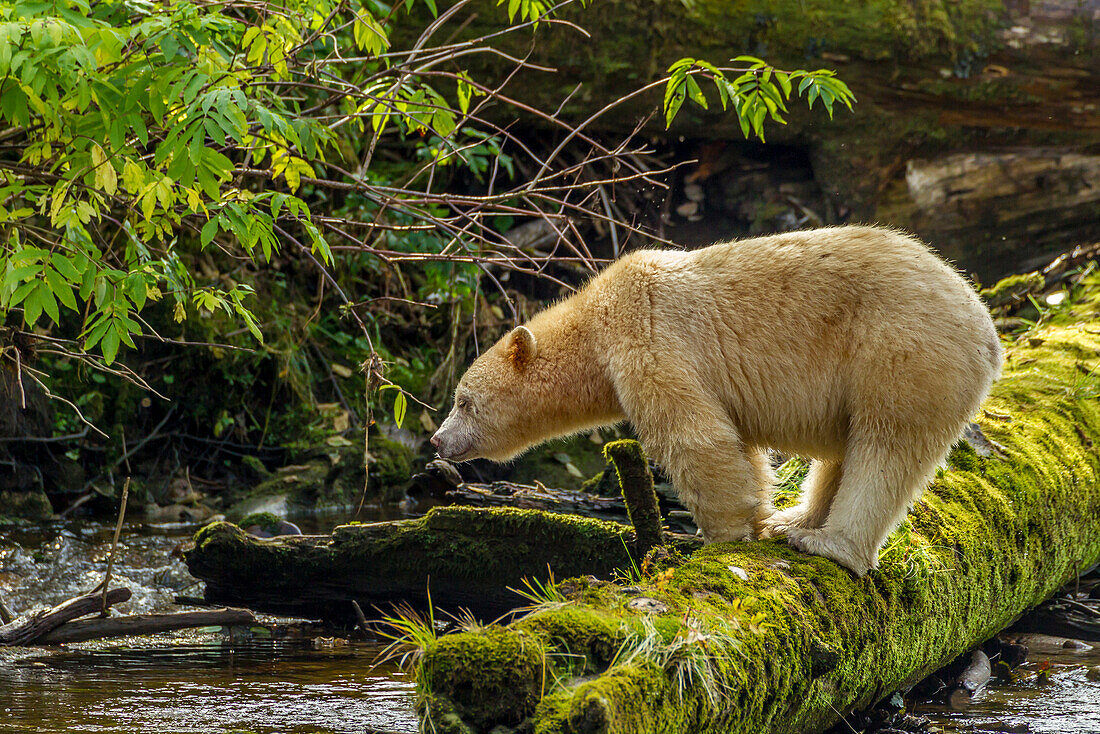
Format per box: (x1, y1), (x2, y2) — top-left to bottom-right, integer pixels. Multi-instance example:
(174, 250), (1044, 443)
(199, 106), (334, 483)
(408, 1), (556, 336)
(416, 275), (1100, 734)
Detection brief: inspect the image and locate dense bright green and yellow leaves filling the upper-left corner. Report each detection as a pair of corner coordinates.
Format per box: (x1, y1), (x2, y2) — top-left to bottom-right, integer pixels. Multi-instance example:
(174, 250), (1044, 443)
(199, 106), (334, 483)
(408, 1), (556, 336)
(0, 0), (332, 363)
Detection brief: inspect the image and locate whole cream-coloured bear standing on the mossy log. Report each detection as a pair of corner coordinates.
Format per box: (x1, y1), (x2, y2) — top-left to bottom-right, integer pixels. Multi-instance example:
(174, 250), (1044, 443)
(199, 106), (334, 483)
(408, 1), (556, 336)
(432, 227), (1001, 573)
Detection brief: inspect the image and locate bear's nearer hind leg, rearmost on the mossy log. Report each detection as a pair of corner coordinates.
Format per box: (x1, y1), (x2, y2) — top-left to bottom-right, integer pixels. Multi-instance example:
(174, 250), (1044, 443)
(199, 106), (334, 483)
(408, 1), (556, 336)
(788, 435), (947, 576)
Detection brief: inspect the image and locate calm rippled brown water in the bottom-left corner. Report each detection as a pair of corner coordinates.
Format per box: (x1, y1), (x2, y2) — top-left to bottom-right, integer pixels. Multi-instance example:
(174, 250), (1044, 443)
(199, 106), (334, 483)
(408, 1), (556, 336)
(0, 634), (416, 734)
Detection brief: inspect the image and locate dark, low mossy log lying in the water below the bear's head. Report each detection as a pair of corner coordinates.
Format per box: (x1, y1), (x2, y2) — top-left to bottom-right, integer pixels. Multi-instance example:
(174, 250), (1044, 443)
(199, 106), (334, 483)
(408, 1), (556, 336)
(185, 507), (693, 623)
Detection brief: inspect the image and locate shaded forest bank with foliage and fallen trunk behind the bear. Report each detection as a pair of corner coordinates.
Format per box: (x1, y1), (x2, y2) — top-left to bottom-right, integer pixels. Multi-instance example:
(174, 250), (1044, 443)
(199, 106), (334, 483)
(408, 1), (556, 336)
(0, 0), (1100, 516)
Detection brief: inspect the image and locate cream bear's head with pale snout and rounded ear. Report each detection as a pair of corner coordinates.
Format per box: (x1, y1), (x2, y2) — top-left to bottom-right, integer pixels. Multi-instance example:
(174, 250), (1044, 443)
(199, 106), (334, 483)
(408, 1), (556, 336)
(431, 326), (538, 461)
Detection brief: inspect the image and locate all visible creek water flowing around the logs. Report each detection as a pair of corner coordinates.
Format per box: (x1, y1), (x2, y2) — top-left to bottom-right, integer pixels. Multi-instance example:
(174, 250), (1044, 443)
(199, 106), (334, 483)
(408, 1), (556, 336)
(0, 518), (1100, 734)
